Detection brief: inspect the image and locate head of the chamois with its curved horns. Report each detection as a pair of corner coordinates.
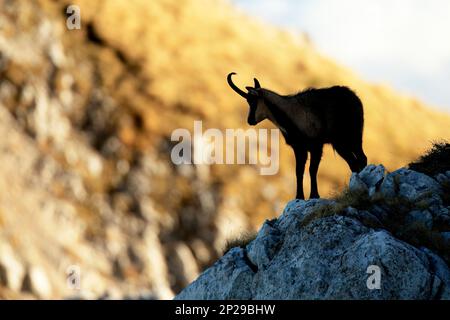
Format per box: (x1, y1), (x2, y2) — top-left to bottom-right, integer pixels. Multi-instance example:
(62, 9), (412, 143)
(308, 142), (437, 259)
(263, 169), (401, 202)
(227, 72), (268, 126)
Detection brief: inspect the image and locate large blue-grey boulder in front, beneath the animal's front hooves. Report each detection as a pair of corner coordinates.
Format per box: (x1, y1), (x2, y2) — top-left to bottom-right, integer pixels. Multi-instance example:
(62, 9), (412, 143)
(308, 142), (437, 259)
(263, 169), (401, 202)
(177, 200), (450, 299)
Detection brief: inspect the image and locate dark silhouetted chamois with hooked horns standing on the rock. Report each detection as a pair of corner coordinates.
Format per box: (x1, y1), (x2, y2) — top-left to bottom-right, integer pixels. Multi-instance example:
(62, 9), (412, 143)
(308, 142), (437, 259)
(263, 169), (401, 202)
(227, 72), (367, 199)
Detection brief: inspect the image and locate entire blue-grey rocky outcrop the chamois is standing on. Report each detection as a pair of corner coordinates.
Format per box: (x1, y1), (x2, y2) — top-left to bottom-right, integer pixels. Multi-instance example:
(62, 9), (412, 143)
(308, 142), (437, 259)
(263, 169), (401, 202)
(176, 166), (450, 299)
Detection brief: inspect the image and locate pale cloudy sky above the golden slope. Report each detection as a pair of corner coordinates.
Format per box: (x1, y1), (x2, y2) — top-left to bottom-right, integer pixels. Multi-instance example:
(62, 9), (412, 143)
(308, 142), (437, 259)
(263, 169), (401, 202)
(231, 0), (450, 112)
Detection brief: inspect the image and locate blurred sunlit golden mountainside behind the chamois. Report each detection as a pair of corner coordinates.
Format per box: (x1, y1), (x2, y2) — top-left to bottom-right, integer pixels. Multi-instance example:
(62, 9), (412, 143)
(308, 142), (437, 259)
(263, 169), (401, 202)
(0, 0), (450, 298)
